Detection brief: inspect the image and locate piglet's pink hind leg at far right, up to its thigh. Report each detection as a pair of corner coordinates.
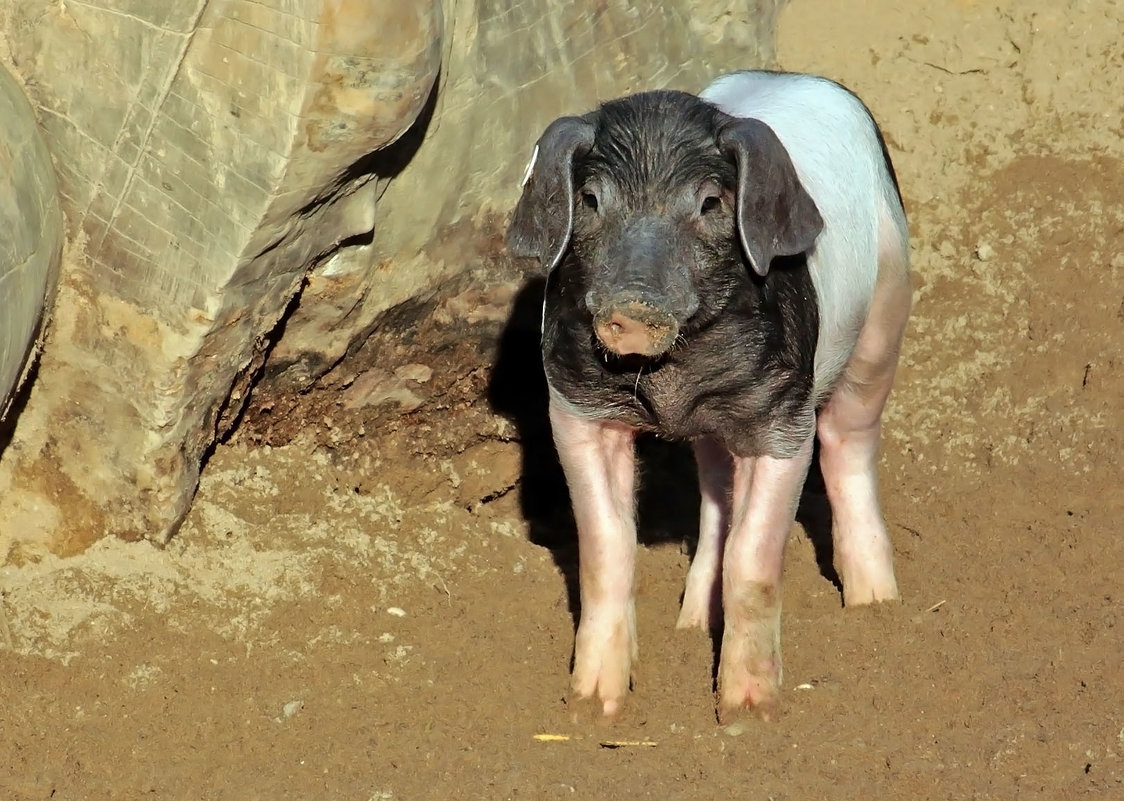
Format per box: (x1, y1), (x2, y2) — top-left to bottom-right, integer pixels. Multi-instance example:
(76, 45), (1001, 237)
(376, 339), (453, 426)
(816, 252), (910, 607)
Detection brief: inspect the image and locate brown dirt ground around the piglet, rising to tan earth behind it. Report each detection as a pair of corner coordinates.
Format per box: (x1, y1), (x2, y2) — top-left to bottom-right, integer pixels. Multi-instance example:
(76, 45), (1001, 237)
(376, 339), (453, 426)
(0, 0), (1124, 801)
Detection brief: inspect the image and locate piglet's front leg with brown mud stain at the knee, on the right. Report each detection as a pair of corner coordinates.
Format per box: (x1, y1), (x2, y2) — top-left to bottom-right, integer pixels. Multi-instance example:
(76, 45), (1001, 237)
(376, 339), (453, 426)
(718, 434), (813, 722)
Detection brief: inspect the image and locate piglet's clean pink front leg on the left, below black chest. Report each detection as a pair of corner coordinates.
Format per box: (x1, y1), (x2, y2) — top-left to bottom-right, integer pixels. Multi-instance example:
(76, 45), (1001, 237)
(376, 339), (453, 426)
(550, 399), (637, 717)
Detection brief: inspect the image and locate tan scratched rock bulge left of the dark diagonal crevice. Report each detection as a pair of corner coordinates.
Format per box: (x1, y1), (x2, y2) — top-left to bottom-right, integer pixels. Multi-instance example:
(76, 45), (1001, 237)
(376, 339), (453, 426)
(0, 0), (442, 553)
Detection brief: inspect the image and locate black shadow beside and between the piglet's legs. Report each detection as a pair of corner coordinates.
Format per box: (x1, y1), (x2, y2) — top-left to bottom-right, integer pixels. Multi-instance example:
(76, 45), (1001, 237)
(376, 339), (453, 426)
(488, 276), (840, 642)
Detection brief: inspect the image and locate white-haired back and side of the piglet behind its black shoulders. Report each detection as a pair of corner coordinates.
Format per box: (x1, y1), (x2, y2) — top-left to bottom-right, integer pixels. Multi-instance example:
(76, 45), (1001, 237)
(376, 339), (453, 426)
(699, 72), (908, 397)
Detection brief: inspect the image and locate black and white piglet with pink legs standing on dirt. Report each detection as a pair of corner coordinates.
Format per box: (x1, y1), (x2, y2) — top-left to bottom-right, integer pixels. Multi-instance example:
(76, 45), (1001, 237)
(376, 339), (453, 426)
(507, 72), (910, 721)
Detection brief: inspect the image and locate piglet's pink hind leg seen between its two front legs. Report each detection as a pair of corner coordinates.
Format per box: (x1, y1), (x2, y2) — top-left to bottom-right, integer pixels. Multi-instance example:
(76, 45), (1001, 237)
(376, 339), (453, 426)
(676, 438), (734, 630)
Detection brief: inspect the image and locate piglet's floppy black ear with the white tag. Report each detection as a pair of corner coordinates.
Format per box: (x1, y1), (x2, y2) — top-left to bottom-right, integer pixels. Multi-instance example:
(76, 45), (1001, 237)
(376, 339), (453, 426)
(507, 117), (593, 273)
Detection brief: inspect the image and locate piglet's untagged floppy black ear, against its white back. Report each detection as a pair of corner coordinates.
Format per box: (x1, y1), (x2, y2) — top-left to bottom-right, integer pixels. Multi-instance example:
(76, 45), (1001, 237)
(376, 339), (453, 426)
(718, 119), (824, 276)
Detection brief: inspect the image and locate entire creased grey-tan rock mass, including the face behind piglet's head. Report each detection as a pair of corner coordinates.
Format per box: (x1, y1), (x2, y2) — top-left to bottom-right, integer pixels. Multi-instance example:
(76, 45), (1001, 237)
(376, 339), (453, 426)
(0, 0), (778, 559)
